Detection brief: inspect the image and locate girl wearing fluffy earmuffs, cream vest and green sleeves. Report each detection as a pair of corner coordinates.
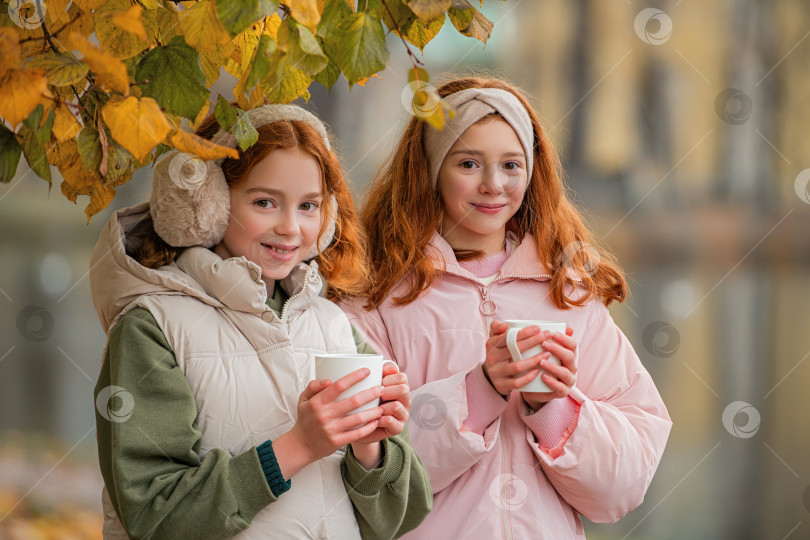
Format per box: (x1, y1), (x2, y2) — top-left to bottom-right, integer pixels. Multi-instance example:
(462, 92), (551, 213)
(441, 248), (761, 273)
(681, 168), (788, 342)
(90, 105), (432, 539)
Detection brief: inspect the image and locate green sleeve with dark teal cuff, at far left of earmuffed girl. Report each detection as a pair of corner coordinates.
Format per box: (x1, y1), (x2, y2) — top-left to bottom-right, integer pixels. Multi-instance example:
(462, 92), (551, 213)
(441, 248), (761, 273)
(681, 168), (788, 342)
(94, 308), (276, 539)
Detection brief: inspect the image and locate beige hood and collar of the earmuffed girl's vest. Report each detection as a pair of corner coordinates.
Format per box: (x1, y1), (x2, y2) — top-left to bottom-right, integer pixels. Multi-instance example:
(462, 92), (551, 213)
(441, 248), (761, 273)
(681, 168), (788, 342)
(90, 203), (316, 333)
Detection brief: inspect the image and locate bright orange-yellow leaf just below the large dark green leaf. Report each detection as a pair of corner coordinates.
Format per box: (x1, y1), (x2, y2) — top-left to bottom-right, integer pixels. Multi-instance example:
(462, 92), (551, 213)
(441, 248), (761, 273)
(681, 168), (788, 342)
(101, 97), (172, 161)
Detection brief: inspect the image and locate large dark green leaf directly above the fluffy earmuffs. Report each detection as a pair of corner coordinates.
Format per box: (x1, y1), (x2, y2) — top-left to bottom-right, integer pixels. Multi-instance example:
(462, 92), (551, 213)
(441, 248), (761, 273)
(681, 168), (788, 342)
(135, 36), (209, 120)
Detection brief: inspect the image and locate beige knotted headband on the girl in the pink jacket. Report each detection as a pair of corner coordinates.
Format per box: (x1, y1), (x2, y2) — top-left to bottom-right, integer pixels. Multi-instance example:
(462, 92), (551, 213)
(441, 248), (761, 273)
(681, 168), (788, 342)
(425, 88), (534, 186)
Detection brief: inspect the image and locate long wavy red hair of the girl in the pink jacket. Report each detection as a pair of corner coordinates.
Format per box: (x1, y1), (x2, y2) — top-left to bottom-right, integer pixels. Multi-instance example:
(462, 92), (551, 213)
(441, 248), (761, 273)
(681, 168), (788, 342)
(360, 77), (627, 309)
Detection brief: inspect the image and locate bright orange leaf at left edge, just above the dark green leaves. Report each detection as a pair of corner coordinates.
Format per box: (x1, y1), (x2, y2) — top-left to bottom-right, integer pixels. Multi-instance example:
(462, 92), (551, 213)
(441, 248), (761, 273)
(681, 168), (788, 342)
(0, 69), (51, 128)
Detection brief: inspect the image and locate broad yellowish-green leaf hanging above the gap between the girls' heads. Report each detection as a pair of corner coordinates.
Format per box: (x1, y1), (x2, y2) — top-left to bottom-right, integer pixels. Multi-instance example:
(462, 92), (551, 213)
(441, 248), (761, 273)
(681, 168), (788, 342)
(335, 12), (388, 87)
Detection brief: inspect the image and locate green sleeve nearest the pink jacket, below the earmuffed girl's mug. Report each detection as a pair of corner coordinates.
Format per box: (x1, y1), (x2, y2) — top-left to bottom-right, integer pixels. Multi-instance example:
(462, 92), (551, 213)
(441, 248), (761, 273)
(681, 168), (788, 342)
(341, 424), (433, 540)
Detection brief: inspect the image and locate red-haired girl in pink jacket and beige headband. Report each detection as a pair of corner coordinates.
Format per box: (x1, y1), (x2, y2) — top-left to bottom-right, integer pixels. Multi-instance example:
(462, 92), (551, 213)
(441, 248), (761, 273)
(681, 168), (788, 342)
(341, 78), (671, 540)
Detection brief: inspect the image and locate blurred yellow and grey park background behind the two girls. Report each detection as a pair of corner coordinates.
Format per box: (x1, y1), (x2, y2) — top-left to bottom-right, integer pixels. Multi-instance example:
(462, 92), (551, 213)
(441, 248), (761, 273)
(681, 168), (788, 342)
(0, 0), (810, 540)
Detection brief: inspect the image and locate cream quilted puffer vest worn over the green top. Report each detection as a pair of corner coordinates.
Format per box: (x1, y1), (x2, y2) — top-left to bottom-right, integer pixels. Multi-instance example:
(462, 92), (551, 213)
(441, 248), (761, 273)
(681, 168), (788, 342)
(91, 207), (360, 539)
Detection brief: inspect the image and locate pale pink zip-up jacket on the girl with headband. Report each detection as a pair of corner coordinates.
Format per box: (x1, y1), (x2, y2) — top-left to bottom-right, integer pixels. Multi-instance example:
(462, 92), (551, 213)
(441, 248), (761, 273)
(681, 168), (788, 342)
(341, 234), (672, 540)
